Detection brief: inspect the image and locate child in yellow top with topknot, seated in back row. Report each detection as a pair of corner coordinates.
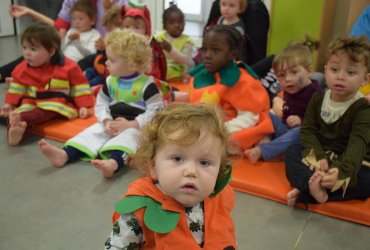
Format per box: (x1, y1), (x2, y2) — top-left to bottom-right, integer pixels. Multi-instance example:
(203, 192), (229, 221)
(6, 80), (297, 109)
(155, 3), (197, 81)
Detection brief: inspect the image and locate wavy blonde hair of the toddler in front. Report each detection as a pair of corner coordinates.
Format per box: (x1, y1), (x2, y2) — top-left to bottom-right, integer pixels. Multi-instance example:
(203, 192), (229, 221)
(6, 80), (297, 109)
(130, 104), (231, 182)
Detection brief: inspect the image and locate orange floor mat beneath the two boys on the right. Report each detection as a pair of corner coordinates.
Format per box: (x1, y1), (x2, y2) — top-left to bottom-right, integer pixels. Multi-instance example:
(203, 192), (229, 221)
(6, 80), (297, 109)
(231, 159), (370, 226)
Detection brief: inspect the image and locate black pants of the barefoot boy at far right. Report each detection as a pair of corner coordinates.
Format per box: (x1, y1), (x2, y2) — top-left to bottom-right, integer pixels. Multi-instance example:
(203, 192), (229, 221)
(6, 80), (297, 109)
(285, 144), (370, 203)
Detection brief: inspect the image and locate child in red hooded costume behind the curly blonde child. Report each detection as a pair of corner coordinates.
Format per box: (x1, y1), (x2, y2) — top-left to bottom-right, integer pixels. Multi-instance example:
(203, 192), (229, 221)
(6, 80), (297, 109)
(121, 6), (167, 81)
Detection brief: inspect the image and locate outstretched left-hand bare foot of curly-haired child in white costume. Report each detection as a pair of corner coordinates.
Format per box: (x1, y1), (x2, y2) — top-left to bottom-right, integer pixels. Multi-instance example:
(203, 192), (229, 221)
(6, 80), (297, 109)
(37, 139), (68, 168)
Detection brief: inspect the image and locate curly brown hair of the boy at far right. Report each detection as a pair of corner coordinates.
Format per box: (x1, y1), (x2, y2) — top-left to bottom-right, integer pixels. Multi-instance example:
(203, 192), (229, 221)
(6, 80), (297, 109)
(326, 36), (370, 72)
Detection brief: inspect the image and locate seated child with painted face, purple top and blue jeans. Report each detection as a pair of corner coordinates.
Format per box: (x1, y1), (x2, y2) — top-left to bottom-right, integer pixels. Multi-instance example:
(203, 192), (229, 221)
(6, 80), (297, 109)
(244, 37), (320, 163)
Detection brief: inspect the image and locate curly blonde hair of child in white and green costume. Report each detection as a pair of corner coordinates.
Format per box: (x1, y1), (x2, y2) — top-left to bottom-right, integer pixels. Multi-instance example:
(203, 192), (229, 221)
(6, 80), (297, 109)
(104, 29), (152, 73)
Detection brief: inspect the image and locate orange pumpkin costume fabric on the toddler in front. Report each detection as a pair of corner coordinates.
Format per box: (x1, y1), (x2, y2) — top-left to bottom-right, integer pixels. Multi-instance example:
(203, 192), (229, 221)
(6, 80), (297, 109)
(113, 177), (236, 250)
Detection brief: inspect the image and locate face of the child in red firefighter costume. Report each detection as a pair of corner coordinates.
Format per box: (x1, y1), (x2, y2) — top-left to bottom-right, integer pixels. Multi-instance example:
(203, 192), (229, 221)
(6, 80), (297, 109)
(22, 41), (55, 67)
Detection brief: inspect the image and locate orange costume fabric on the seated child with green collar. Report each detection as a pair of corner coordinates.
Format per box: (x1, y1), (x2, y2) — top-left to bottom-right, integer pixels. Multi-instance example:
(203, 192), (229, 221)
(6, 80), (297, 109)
(189, 69), (274, 150)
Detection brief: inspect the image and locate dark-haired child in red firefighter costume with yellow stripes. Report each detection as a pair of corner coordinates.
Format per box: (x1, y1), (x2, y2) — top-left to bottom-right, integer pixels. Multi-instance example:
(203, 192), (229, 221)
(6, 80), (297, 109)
(1, 23), (94, 146)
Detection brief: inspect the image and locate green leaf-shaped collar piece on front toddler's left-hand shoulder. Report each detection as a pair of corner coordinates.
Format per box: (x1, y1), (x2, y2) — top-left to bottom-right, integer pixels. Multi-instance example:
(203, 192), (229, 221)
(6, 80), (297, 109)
(115, 196), (180, 234)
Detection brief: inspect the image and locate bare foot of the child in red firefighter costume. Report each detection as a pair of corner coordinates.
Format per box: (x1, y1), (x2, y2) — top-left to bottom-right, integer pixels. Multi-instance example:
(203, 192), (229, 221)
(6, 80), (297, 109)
(8, 111), (27, 146)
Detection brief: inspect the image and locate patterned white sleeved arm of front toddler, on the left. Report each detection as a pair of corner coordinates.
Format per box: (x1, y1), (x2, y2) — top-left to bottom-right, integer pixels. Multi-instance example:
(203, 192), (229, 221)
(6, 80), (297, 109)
(105, 213), (144, 250)
